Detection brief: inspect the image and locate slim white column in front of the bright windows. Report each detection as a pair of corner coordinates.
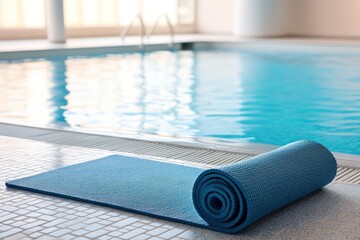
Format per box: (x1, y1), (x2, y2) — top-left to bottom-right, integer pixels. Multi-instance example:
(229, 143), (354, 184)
(45, 0), (66, 43)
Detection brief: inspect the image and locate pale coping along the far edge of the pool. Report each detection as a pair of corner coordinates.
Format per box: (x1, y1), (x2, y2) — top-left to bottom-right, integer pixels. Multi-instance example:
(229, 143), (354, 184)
(0, 34), (360, 61)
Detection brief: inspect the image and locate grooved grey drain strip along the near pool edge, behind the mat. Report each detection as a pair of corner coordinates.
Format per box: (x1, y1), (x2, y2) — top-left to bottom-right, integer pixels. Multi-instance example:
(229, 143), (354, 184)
(0, 124), (360, 184)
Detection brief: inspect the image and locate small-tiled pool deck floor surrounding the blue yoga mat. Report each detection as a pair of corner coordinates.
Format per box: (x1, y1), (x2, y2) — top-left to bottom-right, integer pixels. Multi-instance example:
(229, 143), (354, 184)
(0, 136), (360, 239)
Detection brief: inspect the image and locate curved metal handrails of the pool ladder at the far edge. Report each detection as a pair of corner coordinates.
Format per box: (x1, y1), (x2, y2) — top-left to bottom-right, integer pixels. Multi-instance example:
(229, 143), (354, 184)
(121, 14), (175, 50)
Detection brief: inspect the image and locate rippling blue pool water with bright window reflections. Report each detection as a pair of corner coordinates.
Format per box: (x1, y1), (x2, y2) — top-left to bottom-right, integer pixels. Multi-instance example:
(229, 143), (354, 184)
(0, 49), (360, 154)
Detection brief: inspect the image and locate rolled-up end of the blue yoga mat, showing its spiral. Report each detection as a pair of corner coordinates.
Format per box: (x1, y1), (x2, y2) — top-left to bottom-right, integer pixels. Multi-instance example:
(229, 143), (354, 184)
(193, 140), (337, 233)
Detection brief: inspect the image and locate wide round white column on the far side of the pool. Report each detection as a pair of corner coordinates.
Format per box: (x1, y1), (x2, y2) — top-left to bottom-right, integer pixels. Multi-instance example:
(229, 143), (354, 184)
(234, 0), (292, 37)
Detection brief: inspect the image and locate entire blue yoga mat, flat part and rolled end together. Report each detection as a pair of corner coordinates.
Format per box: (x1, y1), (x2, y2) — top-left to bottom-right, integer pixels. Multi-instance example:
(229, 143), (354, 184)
(6, 141), (336, 233)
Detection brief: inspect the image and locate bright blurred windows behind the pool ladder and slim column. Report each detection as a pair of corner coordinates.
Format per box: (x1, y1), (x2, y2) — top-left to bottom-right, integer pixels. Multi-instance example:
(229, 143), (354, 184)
(0, 0), (195, 39)
